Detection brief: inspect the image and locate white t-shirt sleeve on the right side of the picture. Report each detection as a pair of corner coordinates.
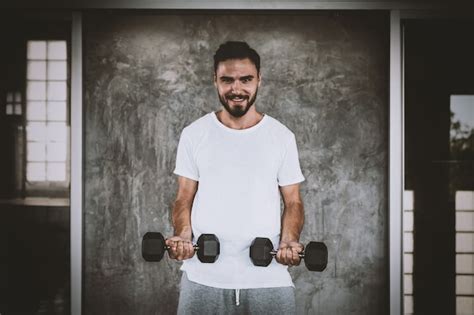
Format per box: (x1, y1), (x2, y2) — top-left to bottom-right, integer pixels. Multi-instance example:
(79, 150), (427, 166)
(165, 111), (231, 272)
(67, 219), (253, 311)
(278, 133), (305, 186)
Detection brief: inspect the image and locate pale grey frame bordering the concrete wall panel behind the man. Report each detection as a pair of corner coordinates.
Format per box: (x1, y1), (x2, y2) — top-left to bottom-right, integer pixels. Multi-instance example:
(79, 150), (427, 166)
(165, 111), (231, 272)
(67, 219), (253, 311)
(70, 6), (466, 315)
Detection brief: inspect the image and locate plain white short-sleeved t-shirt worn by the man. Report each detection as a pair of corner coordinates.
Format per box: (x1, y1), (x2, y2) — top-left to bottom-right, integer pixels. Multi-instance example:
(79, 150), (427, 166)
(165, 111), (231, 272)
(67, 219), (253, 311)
(174, 112), (304, 289)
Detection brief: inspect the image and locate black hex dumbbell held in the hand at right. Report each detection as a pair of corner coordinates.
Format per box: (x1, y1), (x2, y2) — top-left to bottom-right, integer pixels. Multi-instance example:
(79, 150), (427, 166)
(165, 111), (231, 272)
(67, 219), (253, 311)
(250, 237), (328, 271)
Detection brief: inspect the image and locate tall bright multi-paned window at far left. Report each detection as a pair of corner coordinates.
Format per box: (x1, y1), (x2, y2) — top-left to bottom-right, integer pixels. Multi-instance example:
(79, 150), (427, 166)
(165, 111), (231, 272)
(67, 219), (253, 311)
(26, 40), (69, 183)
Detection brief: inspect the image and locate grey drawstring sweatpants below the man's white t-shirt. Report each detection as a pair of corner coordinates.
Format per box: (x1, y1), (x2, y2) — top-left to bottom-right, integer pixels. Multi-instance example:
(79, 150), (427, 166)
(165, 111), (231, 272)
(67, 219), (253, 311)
(178, 272), (296, 315)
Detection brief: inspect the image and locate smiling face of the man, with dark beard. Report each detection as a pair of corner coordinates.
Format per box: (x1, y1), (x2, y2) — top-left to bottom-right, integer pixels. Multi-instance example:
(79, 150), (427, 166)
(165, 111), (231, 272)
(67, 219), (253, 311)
(214, 58), (260, 117)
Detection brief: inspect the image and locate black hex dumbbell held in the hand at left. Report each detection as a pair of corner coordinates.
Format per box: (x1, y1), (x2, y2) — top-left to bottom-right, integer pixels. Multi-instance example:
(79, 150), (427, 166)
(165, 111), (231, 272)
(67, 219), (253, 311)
(142, 232), (220, 263)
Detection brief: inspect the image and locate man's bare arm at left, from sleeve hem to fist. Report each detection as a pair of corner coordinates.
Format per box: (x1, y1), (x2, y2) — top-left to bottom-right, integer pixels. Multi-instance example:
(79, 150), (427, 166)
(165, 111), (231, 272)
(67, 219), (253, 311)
(166, 176), (198, 260)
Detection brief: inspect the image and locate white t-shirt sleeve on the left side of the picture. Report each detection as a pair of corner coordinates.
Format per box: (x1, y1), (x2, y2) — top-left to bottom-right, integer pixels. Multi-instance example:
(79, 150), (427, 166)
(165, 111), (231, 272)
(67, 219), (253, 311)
(173, 129), (199, 181)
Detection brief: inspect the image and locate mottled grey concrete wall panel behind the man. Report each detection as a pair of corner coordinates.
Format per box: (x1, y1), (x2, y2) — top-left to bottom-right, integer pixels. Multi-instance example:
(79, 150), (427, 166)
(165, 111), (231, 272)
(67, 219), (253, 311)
(83, 11), (389, 314)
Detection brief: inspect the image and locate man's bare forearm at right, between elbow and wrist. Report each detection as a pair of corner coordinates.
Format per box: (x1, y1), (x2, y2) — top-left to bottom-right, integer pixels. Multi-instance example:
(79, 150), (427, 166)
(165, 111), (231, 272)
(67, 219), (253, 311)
(280, 201), (304, 242)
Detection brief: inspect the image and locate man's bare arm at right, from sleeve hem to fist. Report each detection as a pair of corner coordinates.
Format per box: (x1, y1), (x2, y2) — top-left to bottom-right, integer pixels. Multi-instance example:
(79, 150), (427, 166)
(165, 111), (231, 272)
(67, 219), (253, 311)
(276, 184), (304, 266)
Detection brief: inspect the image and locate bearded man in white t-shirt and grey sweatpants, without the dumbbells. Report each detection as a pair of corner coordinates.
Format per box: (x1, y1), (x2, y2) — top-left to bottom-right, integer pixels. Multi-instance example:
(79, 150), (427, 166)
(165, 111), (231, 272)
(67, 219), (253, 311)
(166, 42), (304, 314)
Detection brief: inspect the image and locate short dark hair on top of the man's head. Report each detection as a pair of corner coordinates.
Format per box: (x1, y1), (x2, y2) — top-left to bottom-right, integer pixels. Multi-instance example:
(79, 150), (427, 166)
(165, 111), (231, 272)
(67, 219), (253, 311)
(214, 41), (260, 73)
